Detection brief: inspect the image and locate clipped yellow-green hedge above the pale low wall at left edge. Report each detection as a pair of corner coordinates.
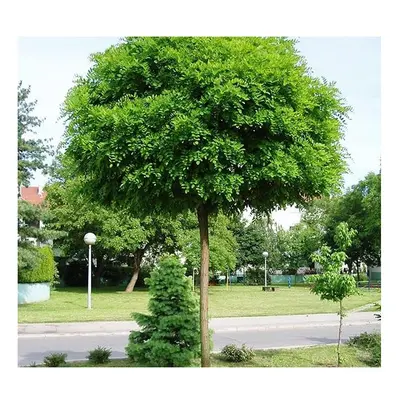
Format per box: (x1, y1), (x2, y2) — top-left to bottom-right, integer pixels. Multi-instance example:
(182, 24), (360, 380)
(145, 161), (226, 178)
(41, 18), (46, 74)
(18, 246), (57, 283)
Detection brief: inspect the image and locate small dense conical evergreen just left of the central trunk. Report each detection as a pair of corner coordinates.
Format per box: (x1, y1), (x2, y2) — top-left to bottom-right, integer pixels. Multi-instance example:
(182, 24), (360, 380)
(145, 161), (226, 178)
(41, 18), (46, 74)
(126, 256), (200, 367)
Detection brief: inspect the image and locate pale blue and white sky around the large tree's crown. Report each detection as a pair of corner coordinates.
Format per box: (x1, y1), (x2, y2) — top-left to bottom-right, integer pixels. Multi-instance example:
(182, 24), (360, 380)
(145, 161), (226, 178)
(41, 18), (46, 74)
(18, 37), (381, 229)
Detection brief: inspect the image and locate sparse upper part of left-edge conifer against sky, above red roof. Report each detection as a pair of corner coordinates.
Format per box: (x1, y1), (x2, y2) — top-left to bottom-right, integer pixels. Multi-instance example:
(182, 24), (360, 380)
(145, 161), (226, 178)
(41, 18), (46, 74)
(18, 81), (51, 186)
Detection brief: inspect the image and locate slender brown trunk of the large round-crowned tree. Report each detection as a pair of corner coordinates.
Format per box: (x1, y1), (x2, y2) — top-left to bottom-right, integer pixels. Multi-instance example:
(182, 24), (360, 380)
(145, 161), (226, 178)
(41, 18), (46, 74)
(197, 204), (210, 367)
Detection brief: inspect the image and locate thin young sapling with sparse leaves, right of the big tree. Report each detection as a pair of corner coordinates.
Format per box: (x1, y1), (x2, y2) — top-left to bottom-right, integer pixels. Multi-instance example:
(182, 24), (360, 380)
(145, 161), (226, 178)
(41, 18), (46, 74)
(308, 222), (357, 367)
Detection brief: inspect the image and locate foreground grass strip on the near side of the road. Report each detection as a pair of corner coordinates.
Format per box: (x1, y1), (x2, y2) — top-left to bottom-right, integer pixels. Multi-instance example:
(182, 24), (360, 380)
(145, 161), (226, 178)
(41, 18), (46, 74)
(34, 345), (376, 368)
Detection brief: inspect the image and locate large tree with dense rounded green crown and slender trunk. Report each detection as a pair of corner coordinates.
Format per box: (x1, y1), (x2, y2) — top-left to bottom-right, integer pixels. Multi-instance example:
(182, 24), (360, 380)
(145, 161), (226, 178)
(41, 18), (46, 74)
(63, 37), (349, 366)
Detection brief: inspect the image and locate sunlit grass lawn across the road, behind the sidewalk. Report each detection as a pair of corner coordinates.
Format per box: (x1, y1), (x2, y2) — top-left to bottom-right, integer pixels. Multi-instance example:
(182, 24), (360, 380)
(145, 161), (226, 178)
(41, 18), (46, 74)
(18, 285), (381, 323)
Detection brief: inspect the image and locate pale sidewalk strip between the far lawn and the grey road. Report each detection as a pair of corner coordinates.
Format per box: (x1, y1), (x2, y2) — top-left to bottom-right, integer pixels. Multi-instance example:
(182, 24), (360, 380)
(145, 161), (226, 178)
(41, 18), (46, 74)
(18, 312), (380, 337)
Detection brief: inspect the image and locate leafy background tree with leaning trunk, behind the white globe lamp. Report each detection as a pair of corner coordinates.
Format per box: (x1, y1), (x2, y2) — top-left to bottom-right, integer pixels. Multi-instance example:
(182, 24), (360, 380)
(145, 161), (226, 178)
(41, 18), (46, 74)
(47, 178), (179, 293)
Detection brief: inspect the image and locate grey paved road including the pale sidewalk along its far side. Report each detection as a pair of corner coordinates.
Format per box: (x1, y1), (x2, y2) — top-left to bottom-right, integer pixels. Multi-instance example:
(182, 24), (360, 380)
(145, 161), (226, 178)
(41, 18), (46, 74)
(18, 313), (380, 366)
